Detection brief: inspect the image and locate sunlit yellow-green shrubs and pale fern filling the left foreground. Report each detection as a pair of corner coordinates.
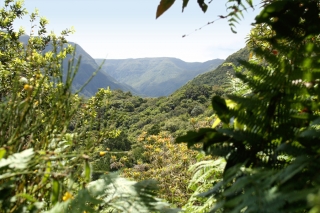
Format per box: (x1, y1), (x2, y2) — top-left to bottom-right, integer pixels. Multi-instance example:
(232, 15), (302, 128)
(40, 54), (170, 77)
(0, 0), (176, 212)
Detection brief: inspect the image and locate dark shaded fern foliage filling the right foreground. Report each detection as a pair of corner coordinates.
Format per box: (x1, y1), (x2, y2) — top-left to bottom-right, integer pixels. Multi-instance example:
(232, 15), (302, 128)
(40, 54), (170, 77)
(177, 1), (320, 212)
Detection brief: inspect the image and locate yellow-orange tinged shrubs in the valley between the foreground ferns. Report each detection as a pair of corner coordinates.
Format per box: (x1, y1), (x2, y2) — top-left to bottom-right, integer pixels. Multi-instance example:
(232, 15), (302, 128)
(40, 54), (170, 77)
(122, 133), (210, 207)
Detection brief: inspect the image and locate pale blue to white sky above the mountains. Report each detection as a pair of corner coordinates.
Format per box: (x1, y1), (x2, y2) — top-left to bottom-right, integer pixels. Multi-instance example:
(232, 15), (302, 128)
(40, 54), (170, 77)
(11, 0), (259, 62)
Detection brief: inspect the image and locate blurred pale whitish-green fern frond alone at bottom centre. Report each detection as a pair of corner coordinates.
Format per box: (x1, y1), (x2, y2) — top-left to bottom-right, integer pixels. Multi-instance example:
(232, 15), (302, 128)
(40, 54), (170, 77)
(87, 173), (178, 213)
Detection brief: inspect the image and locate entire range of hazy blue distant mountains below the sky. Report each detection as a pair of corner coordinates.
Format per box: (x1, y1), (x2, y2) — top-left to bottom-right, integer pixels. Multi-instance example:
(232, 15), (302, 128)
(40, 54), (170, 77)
(20, 35), (231, 97)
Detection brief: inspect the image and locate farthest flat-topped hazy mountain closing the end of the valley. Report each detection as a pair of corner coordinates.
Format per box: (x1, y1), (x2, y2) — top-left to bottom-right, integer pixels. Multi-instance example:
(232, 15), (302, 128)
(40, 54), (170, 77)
(96, 57), (224, 97)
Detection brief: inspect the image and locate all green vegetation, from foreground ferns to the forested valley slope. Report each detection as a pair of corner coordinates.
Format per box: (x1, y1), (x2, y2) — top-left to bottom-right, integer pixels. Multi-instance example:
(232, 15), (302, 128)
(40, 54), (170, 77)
(0, 0), (320, 213)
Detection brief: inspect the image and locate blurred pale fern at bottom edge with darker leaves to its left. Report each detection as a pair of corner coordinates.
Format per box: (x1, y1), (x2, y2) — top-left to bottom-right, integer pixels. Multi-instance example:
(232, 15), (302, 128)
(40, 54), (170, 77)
(47, 174), (177, 213)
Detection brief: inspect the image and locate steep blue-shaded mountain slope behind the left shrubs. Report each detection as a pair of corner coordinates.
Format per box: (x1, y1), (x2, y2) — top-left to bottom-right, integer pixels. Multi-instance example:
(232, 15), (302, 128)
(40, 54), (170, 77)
(20, 35), (138, 97)
